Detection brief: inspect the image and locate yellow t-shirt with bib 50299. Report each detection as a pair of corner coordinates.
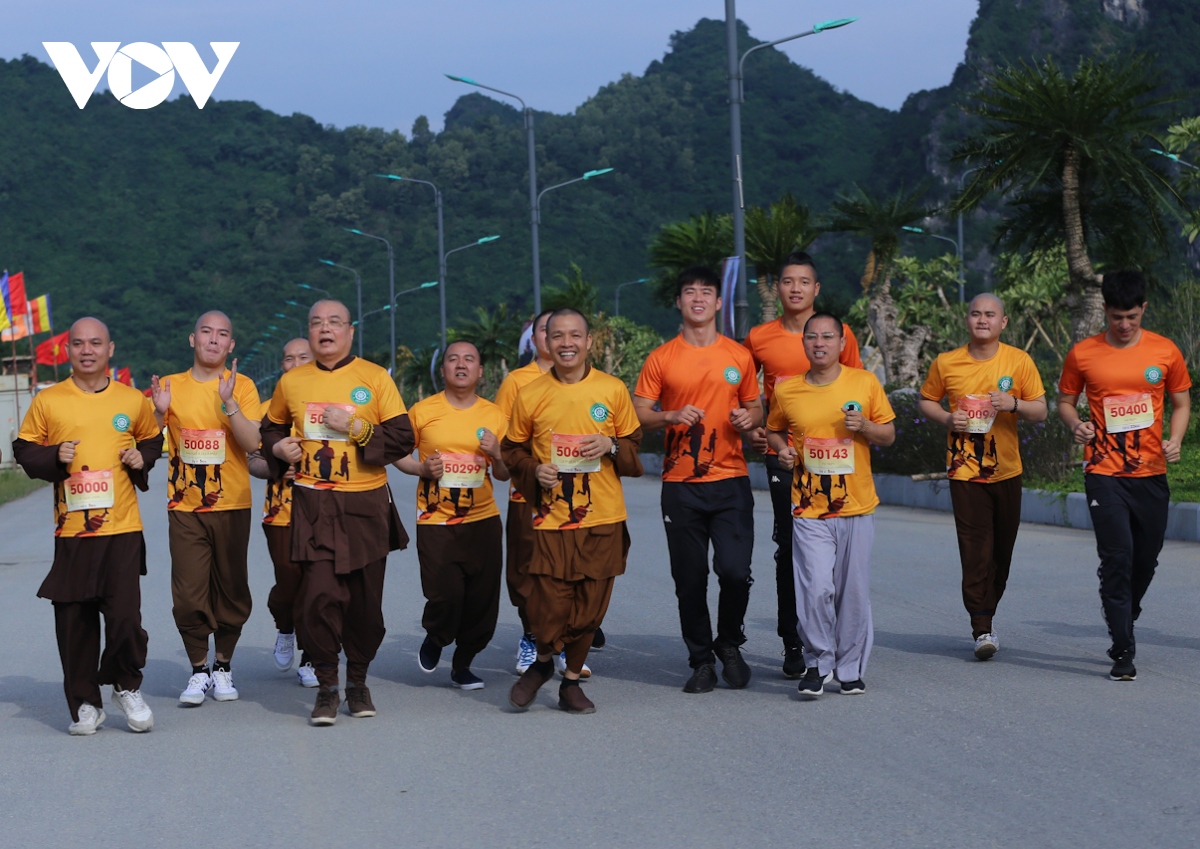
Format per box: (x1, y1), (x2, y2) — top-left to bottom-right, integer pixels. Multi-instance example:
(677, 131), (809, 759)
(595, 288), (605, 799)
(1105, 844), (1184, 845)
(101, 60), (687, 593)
(408, 392), (508, 525)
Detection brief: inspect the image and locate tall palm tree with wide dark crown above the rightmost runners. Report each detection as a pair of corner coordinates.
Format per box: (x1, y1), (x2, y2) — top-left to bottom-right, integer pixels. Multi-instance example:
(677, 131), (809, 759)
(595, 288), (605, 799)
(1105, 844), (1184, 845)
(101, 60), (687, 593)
(954, 56), (1186, 342)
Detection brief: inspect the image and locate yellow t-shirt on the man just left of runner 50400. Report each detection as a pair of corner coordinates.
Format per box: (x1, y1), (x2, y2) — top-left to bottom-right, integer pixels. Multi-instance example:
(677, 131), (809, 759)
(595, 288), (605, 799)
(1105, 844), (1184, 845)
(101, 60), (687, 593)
(920, 343), (1046, 483)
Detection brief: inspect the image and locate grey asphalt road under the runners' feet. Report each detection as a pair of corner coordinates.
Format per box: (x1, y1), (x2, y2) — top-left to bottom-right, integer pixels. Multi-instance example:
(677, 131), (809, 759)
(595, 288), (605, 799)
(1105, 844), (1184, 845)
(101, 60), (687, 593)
(0, 466), (1200, 849)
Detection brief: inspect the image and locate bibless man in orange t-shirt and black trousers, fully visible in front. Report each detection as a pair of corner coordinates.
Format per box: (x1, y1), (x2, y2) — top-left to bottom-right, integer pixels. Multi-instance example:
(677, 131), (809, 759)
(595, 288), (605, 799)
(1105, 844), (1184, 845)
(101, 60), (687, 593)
(634, 267), (762, 693)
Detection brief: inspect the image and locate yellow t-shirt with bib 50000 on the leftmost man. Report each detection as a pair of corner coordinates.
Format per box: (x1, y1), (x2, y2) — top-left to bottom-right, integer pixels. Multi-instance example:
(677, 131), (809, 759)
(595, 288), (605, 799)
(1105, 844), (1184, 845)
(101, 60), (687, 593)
(18, 378), (158, 536)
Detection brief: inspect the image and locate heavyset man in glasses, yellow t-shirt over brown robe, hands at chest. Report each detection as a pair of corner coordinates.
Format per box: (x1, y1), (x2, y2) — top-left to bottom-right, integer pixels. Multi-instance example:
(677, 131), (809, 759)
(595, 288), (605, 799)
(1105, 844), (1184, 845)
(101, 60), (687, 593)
(263, 301), (413, 725)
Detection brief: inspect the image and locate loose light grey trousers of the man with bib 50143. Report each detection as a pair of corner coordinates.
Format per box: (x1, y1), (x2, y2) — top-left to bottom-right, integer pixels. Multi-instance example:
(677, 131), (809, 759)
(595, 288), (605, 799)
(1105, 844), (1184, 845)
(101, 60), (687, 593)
(792, 514), (875, 681)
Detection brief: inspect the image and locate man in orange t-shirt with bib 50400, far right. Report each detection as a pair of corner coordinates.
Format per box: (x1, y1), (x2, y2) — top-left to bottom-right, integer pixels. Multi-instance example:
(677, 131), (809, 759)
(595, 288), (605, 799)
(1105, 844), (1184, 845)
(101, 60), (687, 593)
(1058, 271), (1192, 681)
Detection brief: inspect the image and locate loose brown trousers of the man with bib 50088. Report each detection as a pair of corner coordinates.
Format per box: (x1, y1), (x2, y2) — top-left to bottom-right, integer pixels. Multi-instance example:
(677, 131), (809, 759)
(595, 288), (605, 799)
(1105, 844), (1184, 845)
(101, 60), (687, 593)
(167, 510), (252, 667)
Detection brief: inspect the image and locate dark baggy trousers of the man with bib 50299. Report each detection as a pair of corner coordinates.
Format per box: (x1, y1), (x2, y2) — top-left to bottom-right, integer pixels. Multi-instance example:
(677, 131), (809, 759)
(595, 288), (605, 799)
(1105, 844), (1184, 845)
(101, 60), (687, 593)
(416, 516), (503, 669)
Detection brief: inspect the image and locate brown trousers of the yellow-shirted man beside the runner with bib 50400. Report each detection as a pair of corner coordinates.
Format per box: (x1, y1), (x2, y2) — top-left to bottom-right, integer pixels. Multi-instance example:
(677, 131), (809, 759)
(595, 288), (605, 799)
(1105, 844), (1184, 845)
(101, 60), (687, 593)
(950, 475), (1021, 637)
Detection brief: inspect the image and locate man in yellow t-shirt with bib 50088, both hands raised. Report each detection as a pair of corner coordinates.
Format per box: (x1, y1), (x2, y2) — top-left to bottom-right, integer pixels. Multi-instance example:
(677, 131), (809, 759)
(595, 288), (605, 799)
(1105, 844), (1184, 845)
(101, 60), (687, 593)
(150, 309), (262, 706)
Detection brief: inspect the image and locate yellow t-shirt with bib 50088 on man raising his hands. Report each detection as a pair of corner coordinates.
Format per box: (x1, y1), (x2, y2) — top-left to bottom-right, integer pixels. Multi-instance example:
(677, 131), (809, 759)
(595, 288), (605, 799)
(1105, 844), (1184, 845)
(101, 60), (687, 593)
(163, 369), (263, 513)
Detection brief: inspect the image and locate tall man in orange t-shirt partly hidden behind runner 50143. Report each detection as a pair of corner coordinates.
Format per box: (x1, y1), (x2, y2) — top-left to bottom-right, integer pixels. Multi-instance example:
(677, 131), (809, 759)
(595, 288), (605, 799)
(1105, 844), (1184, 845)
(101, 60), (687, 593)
(743, 251), (863, 679)
